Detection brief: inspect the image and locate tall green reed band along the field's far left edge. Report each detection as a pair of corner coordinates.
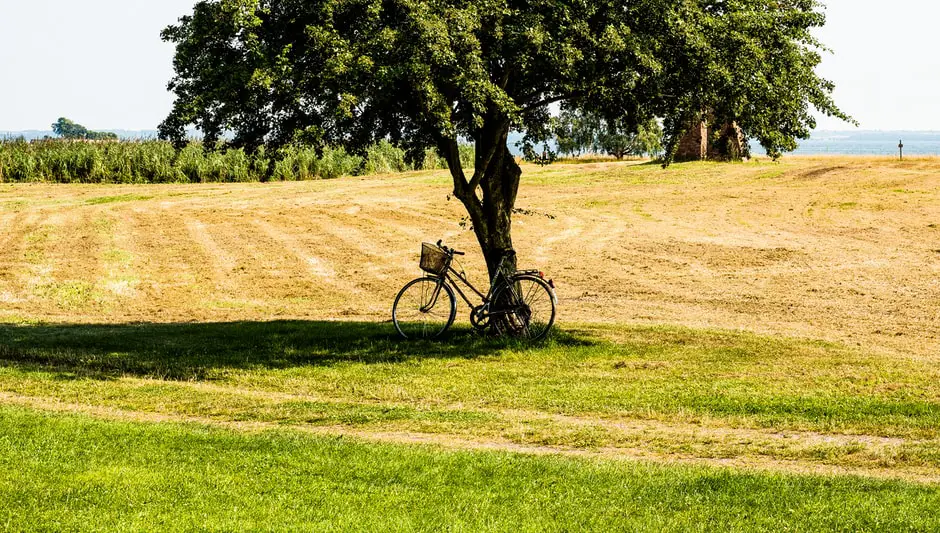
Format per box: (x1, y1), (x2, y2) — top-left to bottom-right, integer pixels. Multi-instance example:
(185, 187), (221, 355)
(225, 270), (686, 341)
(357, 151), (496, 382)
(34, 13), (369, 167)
(0, 139), (473, 183)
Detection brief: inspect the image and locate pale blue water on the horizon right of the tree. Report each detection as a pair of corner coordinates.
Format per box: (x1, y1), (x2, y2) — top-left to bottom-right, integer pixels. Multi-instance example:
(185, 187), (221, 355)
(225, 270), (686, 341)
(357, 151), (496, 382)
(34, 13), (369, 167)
(751, 131), (940, 155)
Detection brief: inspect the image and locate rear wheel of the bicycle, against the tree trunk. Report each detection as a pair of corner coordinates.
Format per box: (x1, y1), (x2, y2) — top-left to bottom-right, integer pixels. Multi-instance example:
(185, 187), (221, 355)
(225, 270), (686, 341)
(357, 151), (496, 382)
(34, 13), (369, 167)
(490, 276), (555, 341)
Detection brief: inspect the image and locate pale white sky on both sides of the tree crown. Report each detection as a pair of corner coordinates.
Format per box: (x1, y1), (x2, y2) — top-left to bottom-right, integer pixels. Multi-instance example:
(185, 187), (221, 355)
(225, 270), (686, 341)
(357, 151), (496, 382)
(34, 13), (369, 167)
(0, 0), (940, 131)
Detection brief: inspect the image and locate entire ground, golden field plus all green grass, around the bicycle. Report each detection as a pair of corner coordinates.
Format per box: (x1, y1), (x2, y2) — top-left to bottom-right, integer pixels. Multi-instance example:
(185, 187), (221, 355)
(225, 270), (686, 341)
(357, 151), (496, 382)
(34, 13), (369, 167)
(0, 158), (940, 530)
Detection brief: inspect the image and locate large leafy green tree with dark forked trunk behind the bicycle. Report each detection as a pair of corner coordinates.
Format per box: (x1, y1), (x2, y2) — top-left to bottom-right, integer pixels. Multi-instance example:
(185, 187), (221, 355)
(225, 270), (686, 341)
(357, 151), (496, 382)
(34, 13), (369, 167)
(160, 0), (844, 273)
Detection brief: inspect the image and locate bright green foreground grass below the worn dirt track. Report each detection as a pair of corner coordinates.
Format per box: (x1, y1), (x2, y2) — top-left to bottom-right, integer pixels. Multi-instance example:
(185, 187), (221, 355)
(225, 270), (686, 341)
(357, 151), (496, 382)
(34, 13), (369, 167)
(0, 407), (940, 531)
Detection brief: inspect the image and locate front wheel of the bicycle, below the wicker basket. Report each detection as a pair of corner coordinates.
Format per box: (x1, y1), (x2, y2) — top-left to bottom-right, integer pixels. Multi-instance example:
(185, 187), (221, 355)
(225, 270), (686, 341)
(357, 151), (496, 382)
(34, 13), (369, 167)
(392, 277), (457, 339)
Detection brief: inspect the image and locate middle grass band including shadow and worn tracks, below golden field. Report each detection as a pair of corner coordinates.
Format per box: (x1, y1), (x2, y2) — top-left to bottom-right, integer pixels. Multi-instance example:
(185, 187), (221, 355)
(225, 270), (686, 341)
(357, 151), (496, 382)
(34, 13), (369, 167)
(0, 322), (940, 479)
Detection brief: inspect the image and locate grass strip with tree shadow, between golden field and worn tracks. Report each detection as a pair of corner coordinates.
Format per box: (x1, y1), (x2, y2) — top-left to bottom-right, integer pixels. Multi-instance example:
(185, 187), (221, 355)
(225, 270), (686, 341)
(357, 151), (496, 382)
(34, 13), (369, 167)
(0, 322), (940, 432)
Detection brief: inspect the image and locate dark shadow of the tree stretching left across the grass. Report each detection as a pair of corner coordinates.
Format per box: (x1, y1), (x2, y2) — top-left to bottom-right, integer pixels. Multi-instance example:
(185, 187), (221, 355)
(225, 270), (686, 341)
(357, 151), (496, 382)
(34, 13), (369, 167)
(0, 321), (595, 380)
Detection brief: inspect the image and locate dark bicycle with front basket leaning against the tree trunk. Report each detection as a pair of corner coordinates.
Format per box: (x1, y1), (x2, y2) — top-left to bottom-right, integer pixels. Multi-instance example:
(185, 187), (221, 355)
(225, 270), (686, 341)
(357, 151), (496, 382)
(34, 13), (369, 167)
(392, 241), (558, 341)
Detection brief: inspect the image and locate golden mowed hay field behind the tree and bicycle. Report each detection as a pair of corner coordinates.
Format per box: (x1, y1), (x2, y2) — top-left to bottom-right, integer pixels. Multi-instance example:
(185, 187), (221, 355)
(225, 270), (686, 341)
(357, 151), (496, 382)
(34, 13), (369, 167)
(0, 157), (940, 360)
